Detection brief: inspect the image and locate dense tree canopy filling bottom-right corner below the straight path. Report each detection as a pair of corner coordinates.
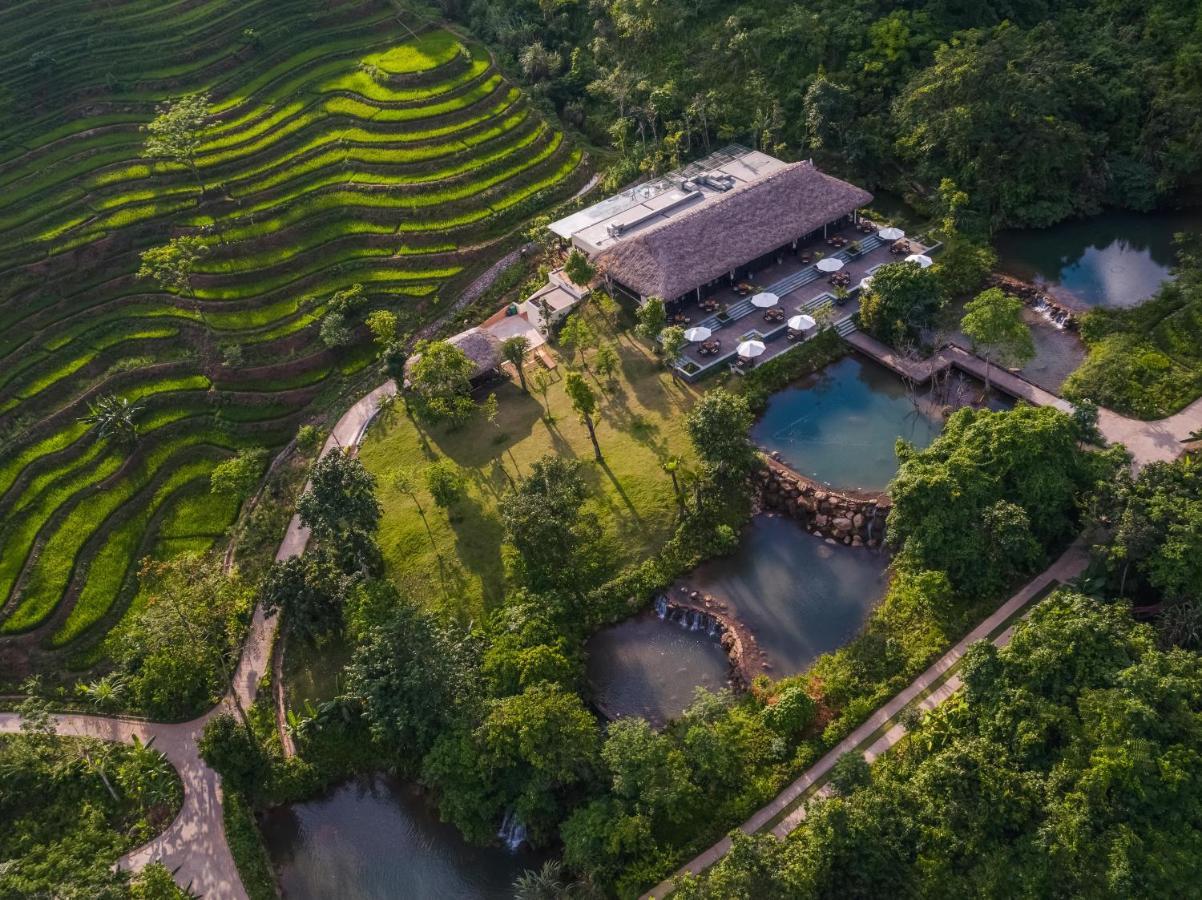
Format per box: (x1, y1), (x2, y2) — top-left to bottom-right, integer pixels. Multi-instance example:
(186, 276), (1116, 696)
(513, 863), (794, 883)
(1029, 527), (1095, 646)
(679, 591), (1202, 900)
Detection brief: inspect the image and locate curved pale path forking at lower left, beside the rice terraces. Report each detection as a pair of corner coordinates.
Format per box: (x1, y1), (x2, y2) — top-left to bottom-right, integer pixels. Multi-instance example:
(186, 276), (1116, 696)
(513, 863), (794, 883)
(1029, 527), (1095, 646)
(0, 381), (397, 900)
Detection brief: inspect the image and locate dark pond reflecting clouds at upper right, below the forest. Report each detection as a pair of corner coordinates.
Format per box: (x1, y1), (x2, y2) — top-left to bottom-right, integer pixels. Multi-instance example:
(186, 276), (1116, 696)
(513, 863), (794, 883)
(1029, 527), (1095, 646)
(994, 210), (1202, 306)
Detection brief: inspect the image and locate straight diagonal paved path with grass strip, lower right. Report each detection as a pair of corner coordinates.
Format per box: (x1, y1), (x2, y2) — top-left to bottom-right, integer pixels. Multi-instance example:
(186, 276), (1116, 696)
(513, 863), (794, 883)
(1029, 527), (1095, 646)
(643, 541), (1089, 900)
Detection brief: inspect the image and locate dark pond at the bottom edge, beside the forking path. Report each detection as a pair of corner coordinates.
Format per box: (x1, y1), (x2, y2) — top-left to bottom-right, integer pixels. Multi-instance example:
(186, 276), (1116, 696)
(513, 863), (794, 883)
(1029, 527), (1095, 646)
(262, 775), (542, 900)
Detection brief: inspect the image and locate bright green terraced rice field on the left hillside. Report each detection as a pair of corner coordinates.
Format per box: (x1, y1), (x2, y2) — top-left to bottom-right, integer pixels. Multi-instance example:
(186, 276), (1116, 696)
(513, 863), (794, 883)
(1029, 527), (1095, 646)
(0, 0), (585, 677)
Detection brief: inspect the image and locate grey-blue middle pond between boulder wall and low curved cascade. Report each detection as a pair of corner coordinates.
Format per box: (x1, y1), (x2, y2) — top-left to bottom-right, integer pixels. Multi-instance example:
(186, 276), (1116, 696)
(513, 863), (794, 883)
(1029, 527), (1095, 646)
(685, 515), (888, 675)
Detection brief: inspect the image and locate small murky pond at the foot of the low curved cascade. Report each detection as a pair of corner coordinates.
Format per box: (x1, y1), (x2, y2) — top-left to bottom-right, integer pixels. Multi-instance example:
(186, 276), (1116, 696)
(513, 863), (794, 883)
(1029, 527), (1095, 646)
(588, 603), (730, 725)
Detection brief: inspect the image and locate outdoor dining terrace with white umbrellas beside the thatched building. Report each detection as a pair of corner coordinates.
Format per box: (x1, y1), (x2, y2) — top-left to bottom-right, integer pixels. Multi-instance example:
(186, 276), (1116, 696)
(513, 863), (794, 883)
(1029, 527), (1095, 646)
(668, 225), (934, 381)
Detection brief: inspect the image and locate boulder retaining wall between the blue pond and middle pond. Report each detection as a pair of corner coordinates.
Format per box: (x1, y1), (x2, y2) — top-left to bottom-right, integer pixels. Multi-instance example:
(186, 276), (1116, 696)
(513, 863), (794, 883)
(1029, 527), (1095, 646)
(757, 458), (891, 547)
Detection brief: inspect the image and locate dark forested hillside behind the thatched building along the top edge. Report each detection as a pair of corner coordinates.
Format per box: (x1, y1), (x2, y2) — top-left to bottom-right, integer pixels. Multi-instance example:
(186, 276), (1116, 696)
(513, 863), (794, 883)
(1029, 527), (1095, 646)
(439, 0), (1202, 228)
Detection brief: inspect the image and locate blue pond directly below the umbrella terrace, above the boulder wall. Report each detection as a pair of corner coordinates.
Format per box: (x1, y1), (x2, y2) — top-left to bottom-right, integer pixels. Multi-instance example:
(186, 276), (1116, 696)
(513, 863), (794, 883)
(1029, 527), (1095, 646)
(751, 354), (944, 490)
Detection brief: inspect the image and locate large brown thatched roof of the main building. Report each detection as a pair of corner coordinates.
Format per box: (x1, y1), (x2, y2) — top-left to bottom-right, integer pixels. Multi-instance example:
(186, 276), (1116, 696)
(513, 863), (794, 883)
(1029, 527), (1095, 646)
(596, 162), (873, 299)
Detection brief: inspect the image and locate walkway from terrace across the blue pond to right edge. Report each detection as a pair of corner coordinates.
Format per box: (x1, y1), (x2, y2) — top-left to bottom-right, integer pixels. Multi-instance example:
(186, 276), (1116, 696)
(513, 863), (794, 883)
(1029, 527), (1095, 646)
(845, 332), (1202, 469)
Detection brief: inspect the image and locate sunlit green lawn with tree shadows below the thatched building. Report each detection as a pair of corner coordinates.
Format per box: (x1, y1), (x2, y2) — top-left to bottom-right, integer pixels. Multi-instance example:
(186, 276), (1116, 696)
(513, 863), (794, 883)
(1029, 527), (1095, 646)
(361, 308), (697, 620)
